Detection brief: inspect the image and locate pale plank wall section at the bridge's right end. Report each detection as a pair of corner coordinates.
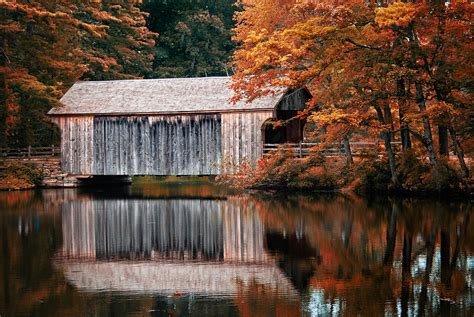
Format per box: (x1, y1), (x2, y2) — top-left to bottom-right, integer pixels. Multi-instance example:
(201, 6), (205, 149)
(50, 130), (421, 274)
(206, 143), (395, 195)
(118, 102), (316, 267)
(221, 111), (273, 173)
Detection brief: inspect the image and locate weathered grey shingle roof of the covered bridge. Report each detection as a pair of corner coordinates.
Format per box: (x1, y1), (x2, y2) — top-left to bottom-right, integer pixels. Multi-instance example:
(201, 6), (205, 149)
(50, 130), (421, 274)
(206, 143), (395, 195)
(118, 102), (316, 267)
(48, 77), (283, 115)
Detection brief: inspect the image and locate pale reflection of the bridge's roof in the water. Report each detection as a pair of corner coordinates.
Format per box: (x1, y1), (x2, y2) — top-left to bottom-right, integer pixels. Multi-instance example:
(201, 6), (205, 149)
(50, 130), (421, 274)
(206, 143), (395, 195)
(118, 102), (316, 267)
(55, 260), (298, 299)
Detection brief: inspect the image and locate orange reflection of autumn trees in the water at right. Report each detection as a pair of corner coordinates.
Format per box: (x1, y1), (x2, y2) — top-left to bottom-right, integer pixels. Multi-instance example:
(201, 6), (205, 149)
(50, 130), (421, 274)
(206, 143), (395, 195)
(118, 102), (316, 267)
(250, 196), (472, 316)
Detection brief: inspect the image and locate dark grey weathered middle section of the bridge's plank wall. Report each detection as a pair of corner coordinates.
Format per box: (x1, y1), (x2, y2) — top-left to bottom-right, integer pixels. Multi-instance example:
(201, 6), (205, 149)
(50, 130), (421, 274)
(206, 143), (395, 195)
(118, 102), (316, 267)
(93, 115), (221, 175)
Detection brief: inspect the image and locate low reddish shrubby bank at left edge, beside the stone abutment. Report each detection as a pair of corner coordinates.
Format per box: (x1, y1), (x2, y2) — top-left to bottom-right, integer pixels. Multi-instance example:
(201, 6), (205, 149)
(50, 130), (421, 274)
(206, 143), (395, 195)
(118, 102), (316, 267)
(0, 163), (43, 190)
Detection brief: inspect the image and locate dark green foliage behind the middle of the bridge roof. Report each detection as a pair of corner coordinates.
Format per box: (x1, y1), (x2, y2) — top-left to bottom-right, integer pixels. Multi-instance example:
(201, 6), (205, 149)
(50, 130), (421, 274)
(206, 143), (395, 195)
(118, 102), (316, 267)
(143, 0), (236, 78)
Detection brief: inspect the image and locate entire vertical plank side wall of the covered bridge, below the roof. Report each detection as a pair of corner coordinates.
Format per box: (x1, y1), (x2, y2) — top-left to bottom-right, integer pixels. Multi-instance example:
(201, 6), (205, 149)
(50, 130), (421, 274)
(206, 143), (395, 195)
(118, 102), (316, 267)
(55, 110), (272, 175)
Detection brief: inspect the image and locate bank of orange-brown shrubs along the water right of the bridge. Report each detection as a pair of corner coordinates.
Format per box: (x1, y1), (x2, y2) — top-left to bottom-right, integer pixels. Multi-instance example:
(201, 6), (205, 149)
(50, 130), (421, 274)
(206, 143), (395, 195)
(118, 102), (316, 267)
(217, 152), (472, 195)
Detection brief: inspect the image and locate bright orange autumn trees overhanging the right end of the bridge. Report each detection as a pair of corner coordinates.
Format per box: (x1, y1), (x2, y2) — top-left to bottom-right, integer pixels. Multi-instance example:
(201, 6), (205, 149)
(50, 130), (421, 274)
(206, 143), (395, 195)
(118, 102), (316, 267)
(233, 0), (472, 186)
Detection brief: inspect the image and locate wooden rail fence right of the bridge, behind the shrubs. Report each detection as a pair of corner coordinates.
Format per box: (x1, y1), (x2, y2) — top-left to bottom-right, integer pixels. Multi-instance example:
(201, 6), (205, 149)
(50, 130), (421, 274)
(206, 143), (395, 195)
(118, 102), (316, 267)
(263, 142), (401, 157)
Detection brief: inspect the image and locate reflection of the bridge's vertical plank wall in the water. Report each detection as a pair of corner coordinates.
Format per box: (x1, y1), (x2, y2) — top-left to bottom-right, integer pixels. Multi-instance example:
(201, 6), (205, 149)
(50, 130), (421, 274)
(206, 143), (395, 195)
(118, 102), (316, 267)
(60, 198), (264, 263)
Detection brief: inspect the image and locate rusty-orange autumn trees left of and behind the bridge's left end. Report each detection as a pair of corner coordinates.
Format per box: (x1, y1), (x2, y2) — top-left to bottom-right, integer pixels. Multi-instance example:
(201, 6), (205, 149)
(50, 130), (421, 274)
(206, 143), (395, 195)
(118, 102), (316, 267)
(0, 0), (155, 146)
